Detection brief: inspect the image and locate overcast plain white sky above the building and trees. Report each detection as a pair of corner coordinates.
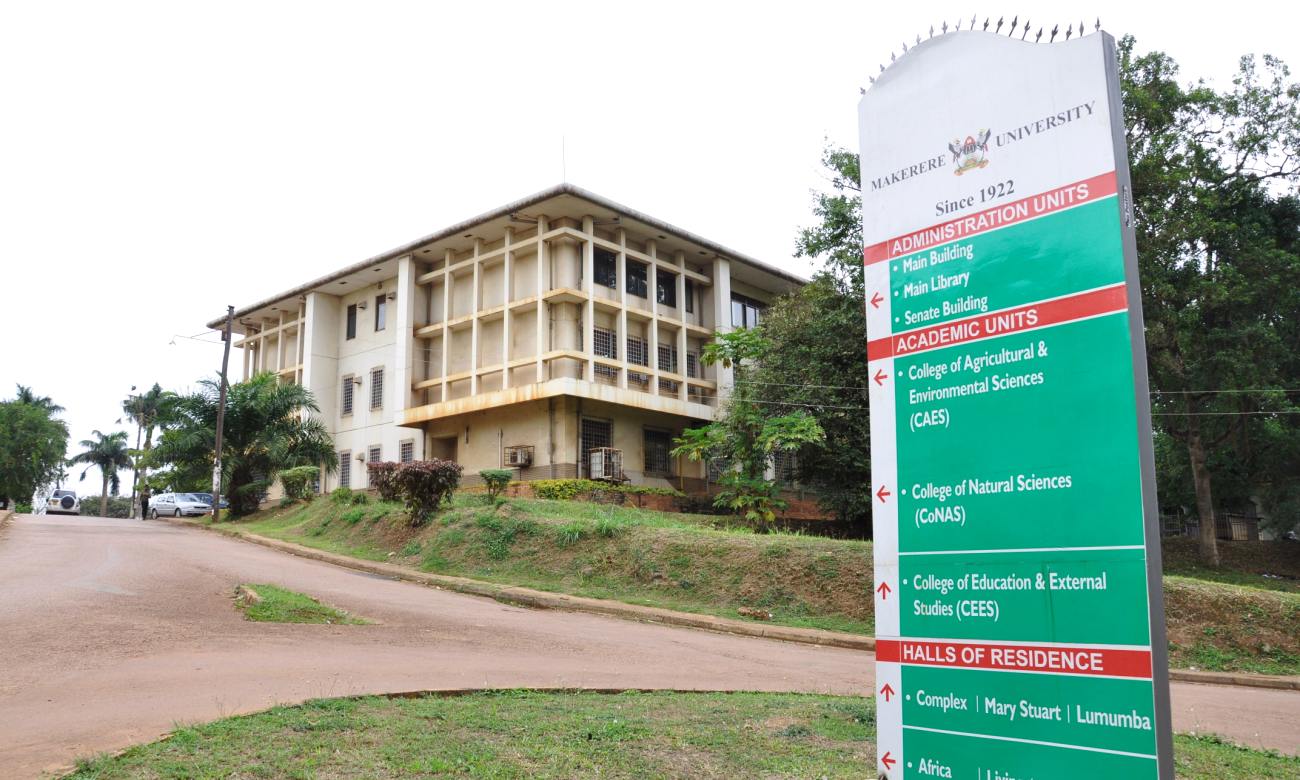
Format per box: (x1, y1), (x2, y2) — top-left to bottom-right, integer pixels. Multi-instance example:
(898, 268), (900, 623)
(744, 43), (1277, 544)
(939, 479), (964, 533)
(0, 0), (1300, 493)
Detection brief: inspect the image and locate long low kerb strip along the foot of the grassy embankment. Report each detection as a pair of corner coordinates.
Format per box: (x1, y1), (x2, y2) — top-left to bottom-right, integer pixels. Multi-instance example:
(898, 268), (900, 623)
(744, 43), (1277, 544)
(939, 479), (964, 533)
(160, 517), (1300, 690)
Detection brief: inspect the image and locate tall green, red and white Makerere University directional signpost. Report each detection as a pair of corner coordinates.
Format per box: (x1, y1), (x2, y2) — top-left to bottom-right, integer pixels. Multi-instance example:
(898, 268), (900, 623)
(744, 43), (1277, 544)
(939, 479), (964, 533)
(859, 31), (1173, 780)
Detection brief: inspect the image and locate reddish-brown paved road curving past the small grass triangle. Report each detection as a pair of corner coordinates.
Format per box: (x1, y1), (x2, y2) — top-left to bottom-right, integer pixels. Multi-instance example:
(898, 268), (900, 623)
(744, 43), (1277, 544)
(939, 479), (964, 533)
(0, 516), (1300, 777)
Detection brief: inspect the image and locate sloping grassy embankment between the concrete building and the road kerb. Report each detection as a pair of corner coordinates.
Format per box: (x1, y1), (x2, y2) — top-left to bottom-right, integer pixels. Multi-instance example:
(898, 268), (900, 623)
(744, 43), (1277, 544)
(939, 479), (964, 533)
(215, 494), (1300, 675)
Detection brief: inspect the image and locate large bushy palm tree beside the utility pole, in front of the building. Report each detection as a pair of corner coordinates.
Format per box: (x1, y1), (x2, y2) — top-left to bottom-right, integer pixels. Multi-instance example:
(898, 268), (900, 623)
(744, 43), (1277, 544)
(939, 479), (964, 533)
(155, 373), (338, 516)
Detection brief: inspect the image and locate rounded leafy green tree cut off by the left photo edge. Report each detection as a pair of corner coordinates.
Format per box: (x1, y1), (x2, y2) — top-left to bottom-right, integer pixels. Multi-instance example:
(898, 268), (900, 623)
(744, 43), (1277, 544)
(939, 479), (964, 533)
(0, 385), (68, 504)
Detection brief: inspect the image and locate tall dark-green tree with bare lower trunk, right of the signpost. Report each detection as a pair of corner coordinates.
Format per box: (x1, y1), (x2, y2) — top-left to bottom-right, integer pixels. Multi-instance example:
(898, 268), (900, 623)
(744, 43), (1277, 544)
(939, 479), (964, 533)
(1119, 36), (1300, 564)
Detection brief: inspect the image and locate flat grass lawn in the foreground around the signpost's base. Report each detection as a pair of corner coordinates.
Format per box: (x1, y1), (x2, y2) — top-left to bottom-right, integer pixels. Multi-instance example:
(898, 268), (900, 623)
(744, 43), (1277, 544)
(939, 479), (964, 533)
(70, 692), (1300, 780)
